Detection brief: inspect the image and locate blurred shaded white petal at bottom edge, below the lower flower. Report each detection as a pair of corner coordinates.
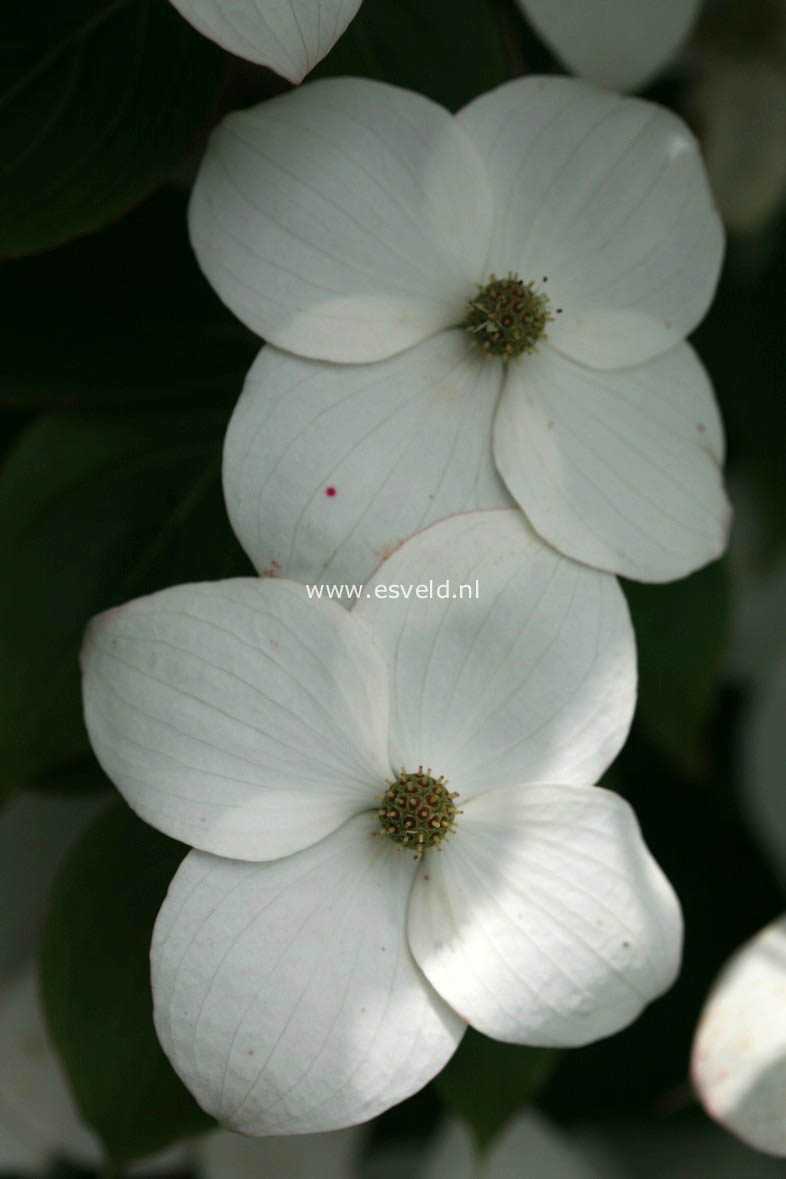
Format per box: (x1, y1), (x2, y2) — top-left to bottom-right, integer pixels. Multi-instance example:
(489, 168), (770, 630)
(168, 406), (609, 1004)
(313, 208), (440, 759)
(194, 1126), (365, 1179)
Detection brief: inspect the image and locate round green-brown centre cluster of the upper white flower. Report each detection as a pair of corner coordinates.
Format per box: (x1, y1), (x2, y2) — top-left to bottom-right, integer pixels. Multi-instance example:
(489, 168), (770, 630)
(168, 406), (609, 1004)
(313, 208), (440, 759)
(462, 274), (561, 361)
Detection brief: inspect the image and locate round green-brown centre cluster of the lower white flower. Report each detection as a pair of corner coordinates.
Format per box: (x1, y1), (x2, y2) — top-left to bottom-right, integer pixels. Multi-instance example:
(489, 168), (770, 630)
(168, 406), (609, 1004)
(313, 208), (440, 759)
(377, 765), (461, 859)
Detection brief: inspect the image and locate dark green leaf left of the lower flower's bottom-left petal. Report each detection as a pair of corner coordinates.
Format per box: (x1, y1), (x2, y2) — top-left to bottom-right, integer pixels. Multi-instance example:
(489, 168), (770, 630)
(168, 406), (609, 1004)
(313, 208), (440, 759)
(41, 803), (211, 1164)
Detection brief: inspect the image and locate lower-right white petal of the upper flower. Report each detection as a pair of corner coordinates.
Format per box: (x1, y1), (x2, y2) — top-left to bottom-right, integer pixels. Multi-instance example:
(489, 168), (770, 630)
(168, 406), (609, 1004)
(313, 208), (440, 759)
(494, 344), (729, 581)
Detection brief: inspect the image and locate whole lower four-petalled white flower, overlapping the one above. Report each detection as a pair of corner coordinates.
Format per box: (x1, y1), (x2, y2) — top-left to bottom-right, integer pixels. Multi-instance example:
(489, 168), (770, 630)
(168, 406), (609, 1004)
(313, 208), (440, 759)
(84, 511), (681, 1134)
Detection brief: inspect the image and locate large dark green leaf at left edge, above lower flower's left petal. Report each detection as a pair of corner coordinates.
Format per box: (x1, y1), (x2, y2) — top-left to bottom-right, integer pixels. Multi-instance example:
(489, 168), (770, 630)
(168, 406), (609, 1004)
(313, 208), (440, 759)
(0, 410), (249, 784)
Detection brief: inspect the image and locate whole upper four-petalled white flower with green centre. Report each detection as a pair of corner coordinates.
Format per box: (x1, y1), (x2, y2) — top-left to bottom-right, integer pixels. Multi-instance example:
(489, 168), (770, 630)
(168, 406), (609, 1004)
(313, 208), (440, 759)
(197, 78), (728, 582)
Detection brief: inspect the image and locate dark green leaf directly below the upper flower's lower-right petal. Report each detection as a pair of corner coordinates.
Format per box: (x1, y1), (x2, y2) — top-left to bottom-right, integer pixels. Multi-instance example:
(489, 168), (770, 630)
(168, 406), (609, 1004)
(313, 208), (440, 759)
(625, 561), (729, 772)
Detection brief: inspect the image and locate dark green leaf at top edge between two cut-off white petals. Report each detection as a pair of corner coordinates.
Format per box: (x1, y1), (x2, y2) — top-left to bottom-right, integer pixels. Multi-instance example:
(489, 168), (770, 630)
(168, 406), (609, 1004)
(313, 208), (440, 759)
(312, 0), (507, 110)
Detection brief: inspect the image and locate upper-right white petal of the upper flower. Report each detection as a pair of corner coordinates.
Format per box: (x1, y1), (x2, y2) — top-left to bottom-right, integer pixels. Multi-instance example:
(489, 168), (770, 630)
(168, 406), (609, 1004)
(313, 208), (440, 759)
(457, 78), (724, 368)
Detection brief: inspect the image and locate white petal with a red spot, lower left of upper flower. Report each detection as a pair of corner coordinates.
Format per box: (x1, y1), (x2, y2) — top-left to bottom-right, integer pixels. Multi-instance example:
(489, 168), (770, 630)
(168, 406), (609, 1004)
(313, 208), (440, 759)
(224, 331), (513, 589)
